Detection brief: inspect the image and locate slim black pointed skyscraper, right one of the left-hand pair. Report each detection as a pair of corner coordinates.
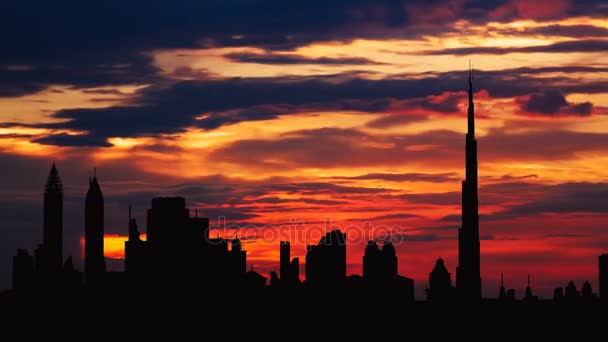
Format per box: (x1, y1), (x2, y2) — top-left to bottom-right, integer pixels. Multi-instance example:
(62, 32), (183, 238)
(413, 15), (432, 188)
(84, 172), (106, 285)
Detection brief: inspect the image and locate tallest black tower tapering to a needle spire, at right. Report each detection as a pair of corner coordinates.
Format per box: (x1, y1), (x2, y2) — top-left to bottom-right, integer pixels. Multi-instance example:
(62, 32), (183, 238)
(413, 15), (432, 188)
(456, 62), (481, 300)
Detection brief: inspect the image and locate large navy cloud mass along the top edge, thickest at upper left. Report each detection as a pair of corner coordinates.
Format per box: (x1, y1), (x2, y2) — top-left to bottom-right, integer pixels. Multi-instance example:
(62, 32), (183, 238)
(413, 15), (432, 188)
(0, 0), (608, 96)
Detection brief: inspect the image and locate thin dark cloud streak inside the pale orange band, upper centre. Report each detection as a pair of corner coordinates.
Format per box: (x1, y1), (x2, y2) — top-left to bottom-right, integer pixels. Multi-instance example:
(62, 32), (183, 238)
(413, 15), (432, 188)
(223, 52), (384, 65)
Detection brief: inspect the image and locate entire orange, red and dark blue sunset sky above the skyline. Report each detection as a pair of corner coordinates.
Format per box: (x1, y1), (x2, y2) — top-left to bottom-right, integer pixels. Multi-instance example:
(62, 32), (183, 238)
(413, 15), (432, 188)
(0, 0), (608, 298)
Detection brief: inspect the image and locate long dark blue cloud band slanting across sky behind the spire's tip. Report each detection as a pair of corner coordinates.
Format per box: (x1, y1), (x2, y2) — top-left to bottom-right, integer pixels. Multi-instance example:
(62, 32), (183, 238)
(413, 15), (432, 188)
(15, 67), (608, 145)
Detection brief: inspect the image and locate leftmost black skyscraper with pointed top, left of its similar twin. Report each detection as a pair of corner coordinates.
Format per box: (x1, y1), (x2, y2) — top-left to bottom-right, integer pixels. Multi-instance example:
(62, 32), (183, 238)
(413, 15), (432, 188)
(36, 163), (63, 273)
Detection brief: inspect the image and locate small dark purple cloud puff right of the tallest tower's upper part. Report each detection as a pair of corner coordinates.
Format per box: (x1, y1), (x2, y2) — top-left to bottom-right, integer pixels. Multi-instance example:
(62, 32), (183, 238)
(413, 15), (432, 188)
(519, 90), (593, 116)
